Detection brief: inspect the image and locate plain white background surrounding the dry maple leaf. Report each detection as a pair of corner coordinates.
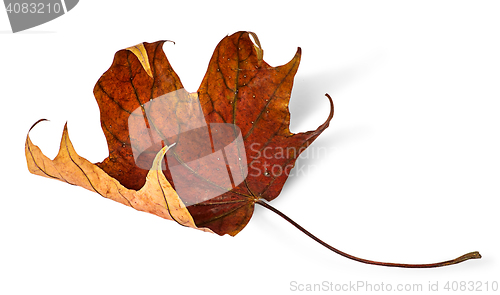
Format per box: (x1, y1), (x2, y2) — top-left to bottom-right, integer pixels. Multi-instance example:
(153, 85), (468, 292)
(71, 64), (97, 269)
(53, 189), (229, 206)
(0, 0), (500, 295)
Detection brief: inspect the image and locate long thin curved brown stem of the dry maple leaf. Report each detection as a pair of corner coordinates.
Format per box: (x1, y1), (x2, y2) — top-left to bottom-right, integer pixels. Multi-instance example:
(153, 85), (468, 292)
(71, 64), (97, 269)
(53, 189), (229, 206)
(256, 200), (481, 268)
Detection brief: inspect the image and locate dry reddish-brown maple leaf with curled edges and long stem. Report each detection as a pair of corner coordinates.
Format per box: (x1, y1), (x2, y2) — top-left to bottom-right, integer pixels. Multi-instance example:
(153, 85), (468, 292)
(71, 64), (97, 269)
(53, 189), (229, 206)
(25, 32), (480, 267)
